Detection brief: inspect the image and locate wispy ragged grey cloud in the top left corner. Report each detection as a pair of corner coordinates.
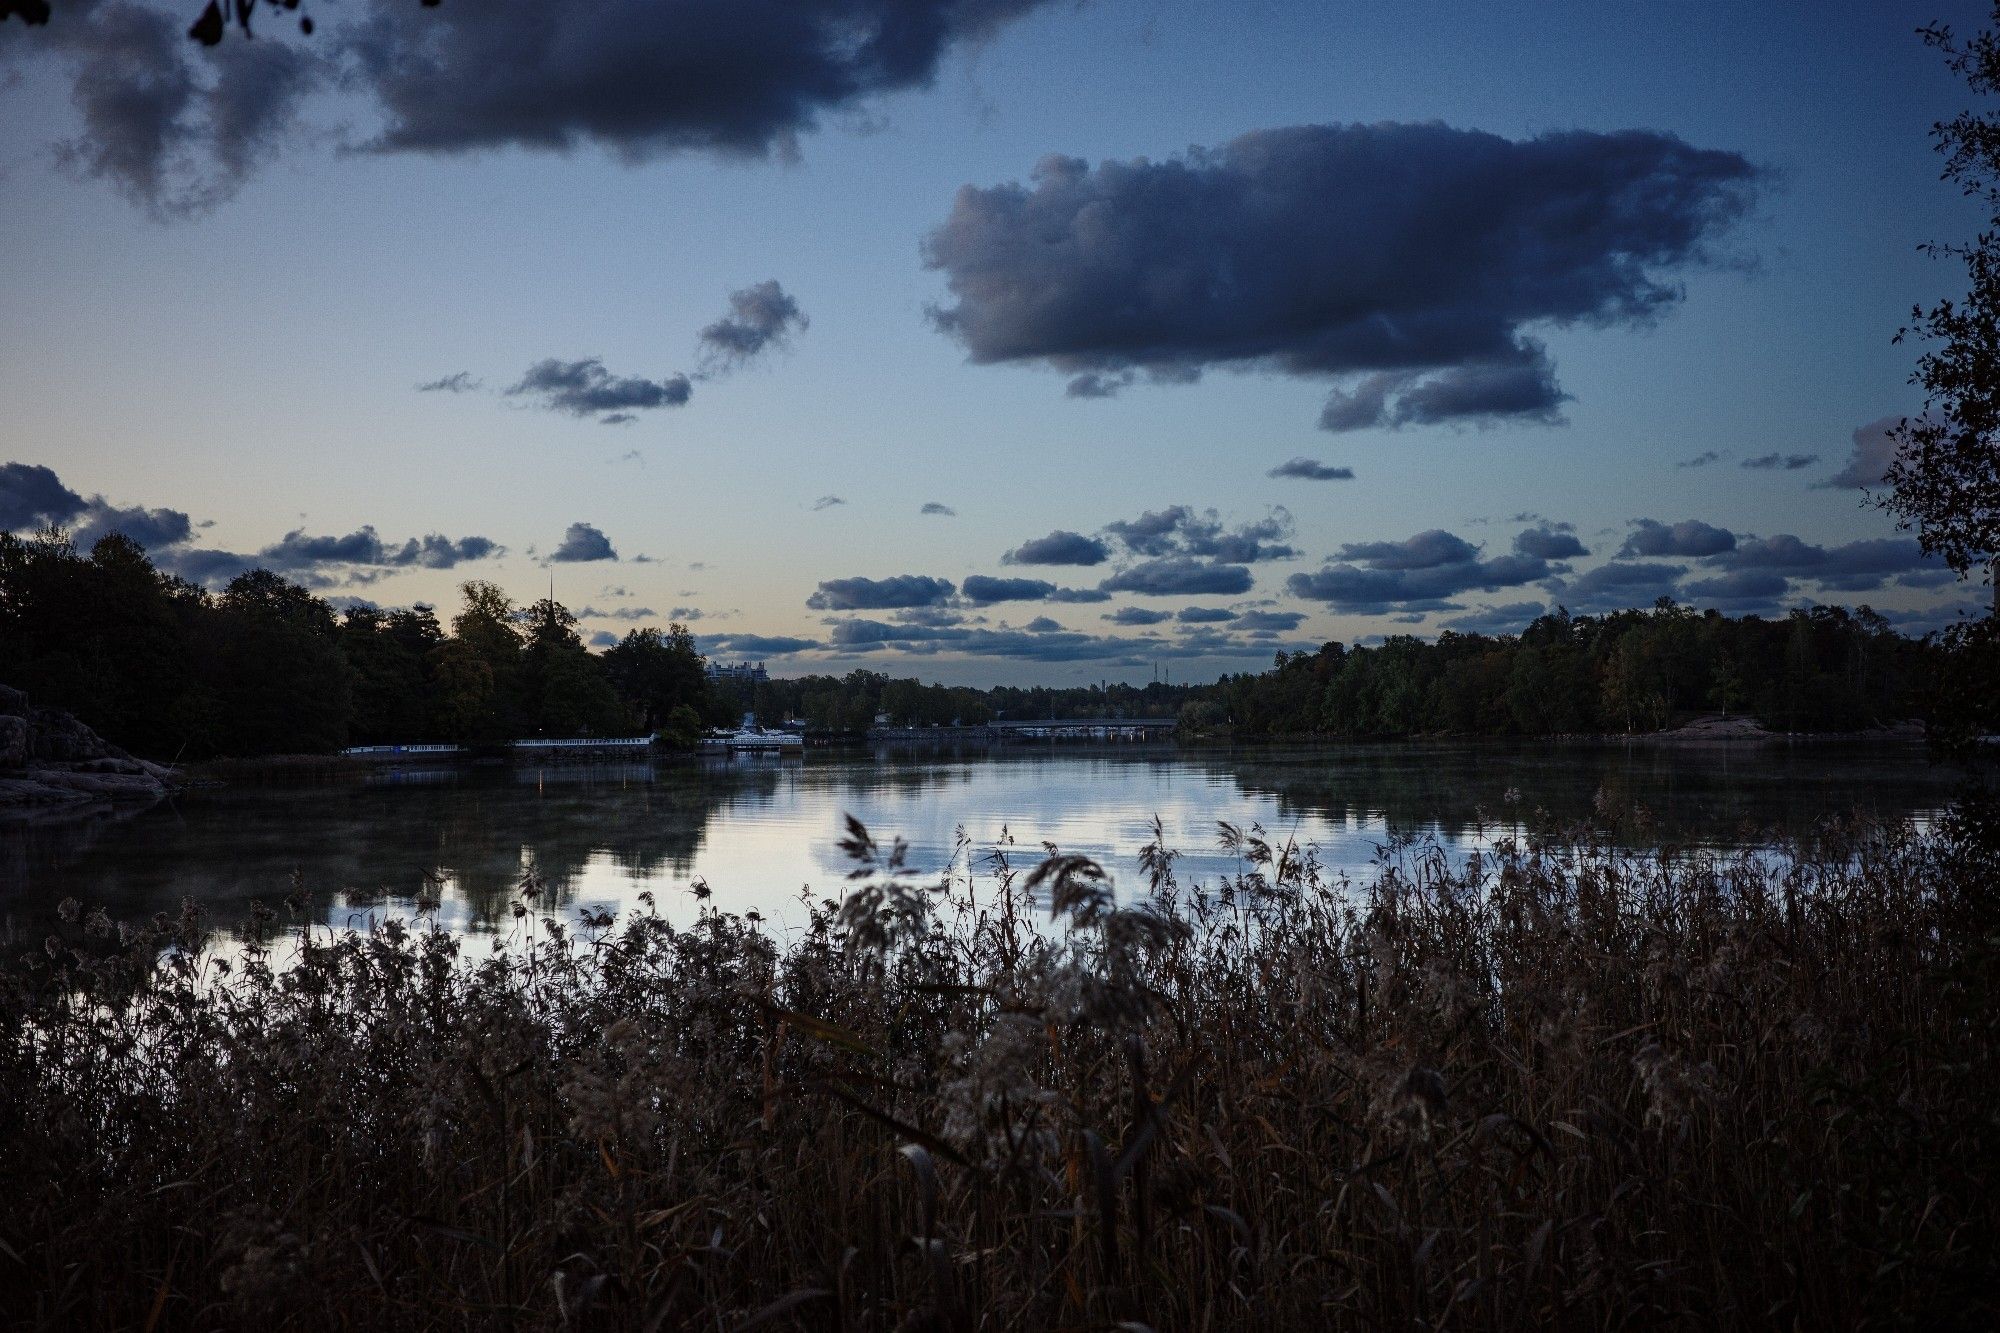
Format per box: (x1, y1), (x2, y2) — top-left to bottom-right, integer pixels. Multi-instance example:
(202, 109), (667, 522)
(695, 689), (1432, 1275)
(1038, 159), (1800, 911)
(22, 0), (328, 218)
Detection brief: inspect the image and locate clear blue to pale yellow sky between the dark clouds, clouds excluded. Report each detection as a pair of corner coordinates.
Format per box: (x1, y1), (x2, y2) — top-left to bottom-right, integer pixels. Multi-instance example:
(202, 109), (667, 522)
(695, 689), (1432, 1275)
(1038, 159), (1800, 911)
(0, 0), (1982, 683)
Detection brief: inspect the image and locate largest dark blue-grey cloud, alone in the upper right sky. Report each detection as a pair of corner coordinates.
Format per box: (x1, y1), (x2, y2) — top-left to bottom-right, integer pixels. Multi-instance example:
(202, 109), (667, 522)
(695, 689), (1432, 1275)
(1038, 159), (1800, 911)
(926, 124), (1758, 430)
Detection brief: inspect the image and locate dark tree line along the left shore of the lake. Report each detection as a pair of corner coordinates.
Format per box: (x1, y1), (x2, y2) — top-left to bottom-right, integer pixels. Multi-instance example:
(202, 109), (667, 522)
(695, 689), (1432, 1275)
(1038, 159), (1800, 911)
(0, 530), (726, 759)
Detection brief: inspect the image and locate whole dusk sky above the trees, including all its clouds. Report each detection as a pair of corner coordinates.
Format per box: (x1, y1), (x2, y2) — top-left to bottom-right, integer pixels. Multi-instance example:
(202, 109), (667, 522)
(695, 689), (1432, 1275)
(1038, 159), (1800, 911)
(0, 0), (1988, 685)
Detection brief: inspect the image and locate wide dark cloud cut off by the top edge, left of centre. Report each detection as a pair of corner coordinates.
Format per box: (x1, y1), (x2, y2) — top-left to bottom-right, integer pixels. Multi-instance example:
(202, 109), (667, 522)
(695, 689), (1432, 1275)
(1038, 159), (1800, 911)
(352, 0), (1040, 162)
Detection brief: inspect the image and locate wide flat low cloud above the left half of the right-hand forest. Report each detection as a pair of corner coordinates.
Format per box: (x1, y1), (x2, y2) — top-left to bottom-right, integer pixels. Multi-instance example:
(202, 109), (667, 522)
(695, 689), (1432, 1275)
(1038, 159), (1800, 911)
(1286, 528), (1556, 614)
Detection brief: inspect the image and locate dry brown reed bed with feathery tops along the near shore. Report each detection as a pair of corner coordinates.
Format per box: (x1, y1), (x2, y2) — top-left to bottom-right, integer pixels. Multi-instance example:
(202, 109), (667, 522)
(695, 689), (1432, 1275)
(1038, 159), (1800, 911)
(0, 804), (2000, 1331)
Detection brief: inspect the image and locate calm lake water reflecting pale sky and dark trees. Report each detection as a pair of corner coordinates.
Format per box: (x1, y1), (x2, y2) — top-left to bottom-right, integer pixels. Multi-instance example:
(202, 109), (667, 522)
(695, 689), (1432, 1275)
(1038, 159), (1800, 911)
(0, 743), (1952, 939)
